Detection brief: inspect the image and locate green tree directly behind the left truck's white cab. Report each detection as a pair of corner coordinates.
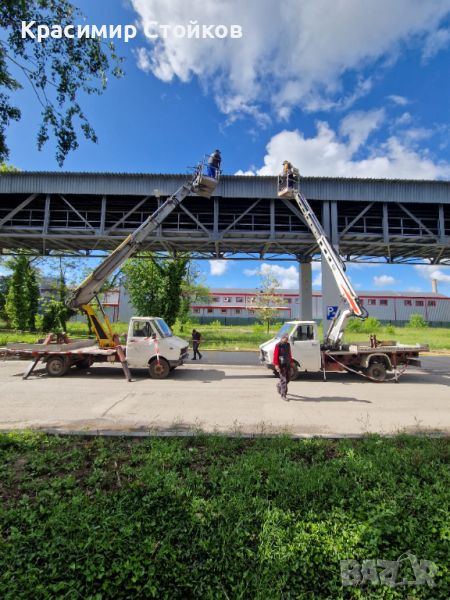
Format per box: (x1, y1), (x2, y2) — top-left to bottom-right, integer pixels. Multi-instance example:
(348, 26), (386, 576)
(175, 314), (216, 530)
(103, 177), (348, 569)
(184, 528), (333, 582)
(122, 252), (189, 326)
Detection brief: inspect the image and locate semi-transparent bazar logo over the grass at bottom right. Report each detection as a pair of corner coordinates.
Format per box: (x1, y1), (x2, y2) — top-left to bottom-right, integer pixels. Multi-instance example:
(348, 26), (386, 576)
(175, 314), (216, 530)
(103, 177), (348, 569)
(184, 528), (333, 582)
(340, 552), (438, 587)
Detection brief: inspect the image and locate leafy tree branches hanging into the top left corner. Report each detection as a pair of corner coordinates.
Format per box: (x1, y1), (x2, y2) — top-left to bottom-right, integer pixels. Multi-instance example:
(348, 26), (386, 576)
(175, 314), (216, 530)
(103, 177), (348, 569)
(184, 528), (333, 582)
(0, 0), (122, 165)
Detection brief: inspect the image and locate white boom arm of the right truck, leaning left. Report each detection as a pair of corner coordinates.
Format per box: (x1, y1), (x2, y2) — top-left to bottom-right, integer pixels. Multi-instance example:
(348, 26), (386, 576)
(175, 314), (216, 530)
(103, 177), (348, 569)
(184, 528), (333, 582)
(278, 169), (367, 346)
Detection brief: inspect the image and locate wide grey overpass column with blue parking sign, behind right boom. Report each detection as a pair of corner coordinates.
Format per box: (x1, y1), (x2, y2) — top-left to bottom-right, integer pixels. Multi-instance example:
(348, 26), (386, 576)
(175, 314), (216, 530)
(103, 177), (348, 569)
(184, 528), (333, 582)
(321, 202), (341, 335)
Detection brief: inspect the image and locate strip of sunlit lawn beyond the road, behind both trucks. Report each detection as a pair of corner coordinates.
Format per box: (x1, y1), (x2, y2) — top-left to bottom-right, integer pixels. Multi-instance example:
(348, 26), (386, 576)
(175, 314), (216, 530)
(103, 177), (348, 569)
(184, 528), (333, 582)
(0, 323), (450, 350)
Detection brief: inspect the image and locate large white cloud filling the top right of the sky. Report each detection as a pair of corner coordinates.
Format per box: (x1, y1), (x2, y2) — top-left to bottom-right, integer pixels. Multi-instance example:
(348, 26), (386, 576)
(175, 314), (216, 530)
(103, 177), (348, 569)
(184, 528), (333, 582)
(131, 0), (450, 121)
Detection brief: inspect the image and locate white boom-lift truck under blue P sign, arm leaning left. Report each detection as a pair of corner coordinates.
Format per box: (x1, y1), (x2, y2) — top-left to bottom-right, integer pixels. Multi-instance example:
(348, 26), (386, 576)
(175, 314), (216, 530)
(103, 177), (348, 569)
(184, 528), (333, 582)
(260, 161), (429, 381)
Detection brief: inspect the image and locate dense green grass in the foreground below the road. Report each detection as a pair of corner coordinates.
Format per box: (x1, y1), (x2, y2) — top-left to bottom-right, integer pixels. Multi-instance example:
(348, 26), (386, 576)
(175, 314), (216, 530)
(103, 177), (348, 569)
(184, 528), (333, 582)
(0, 433), (450, 600)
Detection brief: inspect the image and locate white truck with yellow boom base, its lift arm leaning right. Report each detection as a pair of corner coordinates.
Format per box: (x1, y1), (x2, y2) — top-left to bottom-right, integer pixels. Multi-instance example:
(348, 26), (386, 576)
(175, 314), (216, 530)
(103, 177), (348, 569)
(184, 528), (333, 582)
(7, 159), (220, 380)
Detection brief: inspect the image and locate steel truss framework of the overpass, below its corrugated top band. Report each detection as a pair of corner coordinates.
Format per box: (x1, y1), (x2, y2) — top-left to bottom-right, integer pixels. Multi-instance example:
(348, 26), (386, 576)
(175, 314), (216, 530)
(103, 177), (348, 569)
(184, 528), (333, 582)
(0, 193), (450, 264)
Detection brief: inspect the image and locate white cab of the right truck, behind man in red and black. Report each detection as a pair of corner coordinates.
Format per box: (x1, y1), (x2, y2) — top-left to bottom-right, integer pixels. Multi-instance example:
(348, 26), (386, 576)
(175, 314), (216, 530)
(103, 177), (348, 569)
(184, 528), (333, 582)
(259, 321), (321, 379)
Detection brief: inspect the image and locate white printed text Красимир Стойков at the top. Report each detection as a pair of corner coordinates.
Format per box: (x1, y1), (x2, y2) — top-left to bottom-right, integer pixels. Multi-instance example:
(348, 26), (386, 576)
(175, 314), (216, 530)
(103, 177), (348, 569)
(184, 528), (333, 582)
(21, 21), (243, 42)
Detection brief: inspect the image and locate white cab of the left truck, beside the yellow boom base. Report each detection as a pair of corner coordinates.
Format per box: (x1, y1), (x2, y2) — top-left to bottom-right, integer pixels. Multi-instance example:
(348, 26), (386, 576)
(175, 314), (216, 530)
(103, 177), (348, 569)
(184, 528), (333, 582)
(126, 317), (189, 379)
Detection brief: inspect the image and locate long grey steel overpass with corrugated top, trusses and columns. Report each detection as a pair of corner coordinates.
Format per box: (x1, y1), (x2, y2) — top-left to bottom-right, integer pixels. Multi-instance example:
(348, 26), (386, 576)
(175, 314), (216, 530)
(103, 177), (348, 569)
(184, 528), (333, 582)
(0, 172), (450, 318)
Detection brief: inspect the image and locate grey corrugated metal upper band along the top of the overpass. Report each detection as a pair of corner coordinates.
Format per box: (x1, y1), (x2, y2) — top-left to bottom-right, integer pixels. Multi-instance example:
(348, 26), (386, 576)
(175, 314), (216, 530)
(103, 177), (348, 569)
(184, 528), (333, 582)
(0, 171), (450, 205)
